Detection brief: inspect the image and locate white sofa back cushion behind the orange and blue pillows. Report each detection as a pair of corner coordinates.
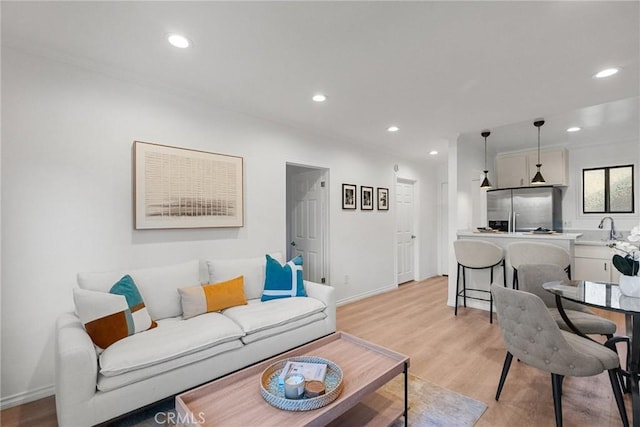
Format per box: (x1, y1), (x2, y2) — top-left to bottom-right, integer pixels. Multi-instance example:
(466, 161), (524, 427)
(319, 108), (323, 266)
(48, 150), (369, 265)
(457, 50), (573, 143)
(206, 252), (284, 300)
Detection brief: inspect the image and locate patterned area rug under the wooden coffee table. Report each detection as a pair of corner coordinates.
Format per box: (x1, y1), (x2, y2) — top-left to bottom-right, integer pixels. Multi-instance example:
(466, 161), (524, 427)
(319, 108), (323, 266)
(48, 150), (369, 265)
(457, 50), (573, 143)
(112, 374), (487, 427)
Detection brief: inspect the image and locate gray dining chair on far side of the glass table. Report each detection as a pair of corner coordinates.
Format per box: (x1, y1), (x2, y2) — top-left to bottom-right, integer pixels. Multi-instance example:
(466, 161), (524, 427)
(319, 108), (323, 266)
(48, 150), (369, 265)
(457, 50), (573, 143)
(518, 264), (616, 338)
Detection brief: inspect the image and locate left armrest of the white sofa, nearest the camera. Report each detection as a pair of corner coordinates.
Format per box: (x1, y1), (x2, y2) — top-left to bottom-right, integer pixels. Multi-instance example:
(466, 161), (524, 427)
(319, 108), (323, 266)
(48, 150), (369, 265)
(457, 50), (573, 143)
(55, 313), (98, 425)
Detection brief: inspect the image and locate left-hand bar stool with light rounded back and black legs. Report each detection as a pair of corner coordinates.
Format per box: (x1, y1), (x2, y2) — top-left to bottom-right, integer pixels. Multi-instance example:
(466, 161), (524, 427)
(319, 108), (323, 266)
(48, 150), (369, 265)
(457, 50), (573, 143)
(453, 239), (507, 323)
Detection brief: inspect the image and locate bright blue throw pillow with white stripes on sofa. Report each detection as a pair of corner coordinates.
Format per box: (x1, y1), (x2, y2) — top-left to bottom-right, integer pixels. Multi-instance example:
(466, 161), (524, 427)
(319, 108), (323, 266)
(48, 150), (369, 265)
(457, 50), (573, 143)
(260, 255), (307, 301)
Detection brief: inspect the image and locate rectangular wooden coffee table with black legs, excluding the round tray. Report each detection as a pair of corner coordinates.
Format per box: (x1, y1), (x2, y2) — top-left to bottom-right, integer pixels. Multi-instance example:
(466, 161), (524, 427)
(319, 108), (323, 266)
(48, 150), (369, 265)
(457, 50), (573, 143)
(176, 332), (409, 427)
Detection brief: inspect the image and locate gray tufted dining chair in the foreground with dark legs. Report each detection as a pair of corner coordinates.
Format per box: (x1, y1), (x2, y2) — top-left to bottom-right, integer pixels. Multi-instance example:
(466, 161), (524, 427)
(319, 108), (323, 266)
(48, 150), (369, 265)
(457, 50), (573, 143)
(491, 283), (629, 427)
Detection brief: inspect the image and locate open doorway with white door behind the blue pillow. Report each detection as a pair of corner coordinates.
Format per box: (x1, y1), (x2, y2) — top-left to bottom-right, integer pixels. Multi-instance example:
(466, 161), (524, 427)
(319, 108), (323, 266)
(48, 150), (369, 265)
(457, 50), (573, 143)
(286, 163), (329, 283)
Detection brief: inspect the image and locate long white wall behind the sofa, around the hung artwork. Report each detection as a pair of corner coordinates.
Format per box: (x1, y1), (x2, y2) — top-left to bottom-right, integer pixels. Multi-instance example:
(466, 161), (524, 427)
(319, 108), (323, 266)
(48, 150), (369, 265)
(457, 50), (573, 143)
(1, 48), (437, 406)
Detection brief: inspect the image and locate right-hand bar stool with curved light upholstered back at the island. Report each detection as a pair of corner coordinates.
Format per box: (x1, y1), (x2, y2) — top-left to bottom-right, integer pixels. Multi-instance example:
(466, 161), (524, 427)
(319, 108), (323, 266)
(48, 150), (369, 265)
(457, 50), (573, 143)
(507, 242), (571, 289)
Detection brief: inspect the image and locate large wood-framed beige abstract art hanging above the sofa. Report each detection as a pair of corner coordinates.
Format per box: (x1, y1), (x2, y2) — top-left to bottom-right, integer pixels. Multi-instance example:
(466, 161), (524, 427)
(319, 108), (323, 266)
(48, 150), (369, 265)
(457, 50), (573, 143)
(133, 141), (244, 230)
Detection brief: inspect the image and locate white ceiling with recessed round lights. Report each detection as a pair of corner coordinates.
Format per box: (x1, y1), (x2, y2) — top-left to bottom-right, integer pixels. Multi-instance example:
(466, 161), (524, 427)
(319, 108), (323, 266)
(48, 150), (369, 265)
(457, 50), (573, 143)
(1, 1), (640, 160)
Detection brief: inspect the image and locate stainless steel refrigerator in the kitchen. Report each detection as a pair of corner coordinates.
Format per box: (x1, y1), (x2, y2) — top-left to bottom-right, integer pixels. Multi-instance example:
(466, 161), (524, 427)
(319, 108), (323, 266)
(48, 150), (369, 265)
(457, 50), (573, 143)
(487, 186), (562, 232)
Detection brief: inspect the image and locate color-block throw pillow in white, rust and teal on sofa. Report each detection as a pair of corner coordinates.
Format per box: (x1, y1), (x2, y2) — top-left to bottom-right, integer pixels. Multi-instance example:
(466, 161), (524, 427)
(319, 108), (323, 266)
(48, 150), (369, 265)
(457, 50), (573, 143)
(73, 276), (156, 349)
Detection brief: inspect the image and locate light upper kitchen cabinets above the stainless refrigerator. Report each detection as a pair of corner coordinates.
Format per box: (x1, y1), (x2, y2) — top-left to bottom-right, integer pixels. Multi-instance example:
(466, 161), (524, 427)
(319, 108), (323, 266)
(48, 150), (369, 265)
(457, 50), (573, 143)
(495, 148), (569, 188)
